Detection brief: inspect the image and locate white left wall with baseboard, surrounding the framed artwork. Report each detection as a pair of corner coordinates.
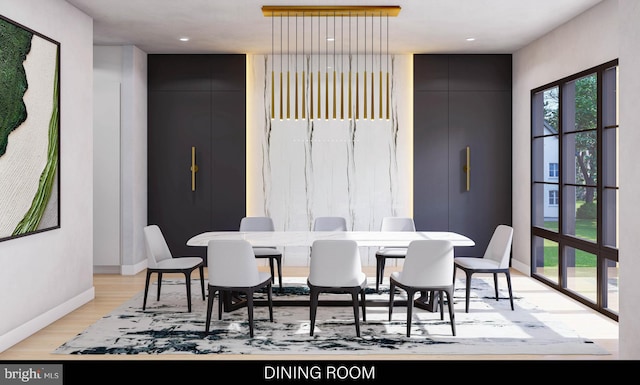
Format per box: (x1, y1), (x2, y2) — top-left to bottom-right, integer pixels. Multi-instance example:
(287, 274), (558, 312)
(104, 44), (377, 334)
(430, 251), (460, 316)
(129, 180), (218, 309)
(0, 0), (94, 351)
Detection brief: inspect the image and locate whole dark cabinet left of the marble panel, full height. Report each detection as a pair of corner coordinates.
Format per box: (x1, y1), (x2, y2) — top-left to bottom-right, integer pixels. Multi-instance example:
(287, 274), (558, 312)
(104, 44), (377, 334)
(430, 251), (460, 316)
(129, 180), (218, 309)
(147, 55), (246, 257)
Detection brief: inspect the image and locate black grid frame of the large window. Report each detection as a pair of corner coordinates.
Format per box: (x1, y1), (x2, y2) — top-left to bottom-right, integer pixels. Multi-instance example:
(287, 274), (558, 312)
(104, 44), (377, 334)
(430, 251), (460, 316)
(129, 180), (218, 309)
(530, 59), (619, 321)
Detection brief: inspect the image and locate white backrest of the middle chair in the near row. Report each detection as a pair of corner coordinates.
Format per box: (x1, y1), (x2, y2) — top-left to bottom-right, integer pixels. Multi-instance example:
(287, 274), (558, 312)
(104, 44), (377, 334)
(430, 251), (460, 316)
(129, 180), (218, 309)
(309, 239), (362, 287)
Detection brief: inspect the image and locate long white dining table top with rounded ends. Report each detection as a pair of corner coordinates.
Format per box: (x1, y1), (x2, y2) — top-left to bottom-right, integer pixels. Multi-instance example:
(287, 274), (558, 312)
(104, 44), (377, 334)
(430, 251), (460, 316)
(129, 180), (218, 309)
(187, 231), (475, 247)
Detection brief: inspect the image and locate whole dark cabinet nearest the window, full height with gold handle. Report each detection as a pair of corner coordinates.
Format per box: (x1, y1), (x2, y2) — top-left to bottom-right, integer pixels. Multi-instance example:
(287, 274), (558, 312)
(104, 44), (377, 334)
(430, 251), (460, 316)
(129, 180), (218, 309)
(414, 55), (512, 256)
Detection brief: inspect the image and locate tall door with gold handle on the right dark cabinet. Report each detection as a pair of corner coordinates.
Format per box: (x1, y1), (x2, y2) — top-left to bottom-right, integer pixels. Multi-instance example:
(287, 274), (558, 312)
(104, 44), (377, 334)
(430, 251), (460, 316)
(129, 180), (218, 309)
(449, 91), (511, 257)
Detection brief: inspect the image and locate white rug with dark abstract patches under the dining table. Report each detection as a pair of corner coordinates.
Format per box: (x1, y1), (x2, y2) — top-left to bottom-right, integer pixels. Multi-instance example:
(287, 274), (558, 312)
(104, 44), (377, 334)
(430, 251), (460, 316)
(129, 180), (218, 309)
(54, 278), (609, 357)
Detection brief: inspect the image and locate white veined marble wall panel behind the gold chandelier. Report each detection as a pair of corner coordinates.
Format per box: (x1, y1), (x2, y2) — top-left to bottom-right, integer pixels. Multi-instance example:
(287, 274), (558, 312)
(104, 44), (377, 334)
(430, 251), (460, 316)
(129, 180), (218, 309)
(247, 55), (413, 265)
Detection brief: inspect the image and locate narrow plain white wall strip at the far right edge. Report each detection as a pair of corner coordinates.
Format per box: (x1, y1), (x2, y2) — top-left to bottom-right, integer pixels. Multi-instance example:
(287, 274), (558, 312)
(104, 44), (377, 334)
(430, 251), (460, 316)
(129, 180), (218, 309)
(618, 0), (640, 360)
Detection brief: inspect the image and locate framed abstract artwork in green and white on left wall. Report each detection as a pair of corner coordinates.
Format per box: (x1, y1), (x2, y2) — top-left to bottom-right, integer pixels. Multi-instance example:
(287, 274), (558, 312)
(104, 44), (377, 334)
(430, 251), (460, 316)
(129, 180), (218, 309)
(0, 15), (60, 241)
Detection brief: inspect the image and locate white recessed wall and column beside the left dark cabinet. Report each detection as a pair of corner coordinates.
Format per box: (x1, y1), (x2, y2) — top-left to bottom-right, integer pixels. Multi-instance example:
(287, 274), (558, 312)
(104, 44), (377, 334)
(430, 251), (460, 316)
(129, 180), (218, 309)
(94, 46), (147, 274)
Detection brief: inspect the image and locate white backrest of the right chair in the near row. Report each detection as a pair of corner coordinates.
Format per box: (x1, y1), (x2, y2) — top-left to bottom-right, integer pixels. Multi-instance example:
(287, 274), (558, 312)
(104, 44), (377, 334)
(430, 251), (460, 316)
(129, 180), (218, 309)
(400, 239), (454, 287)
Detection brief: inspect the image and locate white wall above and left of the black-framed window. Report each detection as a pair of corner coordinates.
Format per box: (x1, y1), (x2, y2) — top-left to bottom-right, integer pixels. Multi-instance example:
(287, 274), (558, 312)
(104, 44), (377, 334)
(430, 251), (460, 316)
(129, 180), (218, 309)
(512, 0), (619, 274)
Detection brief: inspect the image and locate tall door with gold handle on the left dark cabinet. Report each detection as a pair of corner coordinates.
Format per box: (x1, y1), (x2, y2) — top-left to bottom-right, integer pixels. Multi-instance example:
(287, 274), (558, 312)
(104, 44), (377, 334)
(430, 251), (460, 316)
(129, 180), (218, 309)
(148, 91), (213, 255)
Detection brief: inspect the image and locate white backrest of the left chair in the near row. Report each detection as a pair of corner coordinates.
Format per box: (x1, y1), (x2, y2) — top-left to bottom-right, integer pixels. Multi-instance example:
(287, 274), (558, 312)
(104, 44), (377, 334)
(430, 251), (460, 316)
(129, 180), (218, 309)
(207, 239), (260, 287)
